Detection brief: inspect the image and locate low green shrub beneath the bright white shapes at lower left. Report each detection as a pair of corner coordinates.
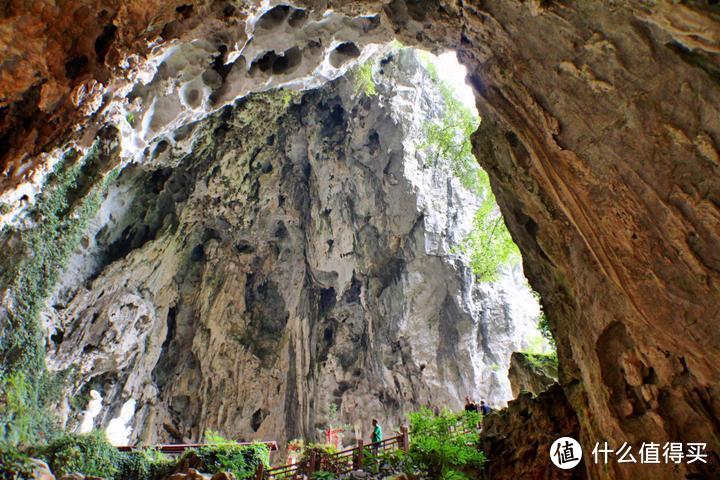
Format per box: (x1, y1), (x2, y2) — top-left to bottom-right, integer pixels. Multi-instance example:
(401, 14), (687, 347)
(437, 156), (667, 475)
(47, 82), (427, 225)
(40, 430), (122, 478)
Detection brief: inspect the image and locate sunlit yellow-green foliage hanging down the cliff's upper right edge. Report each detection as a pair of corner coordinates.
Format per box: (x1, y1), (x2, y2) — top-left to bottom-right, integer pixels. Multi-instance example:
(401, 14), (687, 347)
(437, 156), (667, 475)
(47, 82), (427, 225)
(420, 52), (520, 281)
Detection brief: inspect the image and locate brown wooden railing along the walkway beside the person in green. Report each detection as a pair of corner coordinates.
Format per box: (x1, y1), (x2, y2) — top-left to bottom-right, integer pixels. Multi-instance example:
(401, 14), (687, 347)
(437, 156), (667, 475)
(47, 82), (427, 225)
(255, 427), (409, 480)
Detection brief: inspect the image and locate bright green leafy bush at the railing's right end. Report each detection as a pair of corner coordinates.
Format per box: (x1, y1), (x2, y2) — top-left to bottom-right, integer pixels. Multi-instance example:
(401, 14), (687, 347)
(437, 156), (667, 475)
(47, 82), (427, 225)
(408, 409), (485, 480)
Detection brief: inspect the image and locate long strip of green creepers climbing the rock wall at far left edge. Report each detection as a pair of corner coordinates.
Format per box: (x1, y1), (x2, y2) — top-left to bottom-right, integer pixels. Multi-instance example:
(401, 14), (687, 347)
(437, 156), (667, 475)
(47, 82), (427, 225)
(0, 143), (117, 443)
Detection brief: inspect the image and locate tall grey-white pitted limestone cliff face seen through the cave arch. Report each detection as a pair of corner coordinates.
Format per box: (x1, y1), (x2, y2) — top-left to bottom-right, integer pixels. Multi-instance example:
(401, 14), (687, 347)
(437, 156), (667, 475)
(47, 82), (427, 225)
(39, 50), (534, 442)
